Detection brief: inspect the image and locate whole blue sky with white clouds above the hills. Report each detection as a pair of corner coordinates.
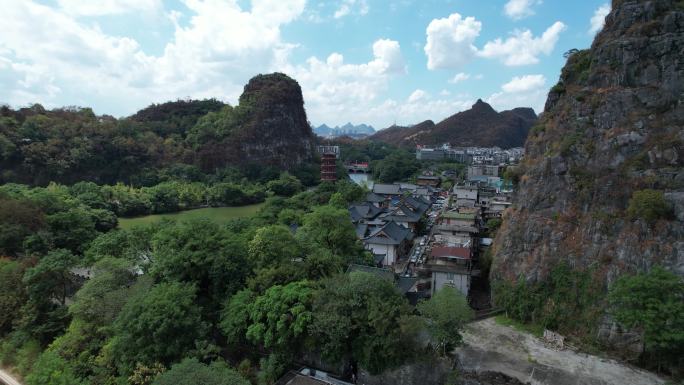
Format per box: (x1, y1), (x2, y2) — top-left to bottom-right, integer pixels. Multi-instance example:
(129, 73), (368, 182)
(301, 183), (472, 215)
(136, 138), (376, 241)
(0, 0), (610, 129)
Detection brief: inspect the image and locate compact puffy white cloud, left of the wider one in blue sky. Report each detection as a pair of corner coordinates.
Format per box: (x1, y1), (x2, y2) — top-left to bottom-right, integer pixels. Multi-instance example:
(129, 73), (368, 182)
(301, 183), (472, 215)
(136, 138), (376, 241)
(424, 13), (482, 70)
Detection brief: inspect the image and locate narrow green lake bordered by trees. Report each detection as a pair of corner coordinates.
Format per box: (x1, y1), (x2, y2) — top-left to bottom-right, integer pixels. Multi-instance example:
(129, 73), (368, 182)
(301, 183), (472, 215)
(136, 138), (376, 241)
(119, 203), (264, 229)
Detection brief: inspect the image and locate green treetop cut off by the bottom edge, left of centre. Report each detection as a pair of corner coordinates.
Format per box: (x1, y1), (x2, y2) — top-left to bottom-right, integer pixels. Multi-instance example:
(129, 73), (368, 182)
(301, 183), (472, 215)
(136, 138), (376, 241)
(152, 358), (249, 385)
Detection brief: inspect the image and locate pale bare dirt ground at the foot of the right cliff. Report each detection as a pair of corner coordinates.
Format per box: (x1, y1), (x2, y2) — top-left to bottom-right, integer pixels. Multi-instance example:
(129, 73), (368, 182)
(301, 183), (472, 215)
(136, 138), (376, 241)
(456, 318), (665, 385)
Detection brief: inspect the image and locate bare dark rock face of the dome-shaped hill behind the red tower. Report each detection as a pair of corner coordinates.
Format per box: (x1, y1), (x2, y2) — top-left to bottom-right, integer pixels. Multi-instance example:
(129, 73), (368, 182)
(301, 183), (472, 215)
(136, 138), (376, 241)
(231, 73), (314, 169)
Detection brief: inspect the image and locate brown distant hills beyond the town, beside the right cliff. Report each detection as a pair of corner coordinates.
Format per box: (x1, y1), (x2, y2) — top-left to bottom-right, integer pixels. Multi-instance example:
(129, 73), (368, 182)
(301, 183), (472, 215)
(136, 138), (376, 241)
(368, 99), (537, 148)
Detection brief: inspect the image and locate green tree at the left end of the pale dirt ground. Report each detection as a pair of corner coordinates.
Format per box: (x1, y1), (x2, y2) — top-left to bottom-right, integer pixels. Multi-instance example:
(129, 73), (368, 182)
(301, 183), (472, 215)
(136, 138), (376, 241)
(418, 286), (473, 355)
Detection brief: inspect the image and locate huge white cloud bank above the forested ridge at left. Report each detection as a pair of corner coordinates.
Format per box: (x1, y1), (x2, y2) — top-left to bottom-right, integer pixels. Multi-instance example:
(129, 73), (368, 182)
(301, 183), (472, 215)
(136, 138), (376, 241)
(0, 0), (305, 115)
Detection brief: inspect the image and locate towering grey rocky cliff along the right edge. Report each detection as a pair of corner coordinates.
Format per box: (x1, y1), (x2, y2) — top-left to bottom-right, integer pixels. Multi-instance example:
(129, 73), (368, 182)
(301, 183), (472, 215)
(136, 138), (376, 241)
(492, 0), (684, 332)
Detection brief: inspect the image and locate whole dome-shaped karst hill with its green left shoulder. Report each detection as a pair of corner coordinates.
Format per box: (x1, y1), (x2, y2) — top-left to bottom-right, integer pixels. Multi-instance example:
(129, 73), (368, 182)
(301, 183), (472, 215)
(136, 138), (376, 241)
(189, 73), (314, 170)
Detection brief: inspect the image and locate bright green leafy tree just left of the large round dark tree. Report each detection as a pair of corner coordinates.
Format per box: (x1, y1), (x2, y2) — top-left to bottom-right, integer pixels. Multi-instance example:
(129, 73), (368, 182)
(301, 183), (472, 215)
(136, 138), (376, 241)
(247, 281), (314, 351)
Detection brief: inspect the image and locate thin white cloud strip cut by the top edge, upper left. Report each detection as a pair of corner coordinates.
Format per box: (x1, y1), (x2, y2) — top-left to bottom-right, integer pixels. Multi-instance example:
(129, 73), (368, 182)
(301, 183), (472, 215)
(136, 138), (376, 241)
(57, 0), (163, 16)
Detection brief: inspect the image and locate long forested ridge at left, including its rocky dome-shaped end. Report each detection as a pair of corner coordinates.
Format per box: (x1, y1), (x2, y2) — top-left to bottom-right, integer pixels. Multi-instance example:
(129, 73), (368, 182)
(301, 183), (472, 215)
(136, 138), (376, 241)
(0, 73), (314, 185)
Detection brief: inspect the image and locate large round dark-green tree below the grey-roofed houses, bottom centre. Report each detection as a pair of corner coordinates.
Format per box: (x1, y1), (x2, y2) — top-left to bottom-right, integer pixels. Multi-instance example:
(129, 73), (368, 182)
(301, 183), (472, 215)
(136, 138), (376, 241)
(310, 272), (415, 373)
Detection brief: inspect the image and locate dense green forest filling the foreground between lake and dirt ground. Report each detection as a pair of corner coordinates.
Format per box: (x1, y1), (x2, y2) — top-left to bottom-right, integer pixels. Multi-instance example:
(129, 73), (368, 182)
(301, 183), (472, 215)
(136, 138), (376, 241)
(0, 176), (470, 385)
